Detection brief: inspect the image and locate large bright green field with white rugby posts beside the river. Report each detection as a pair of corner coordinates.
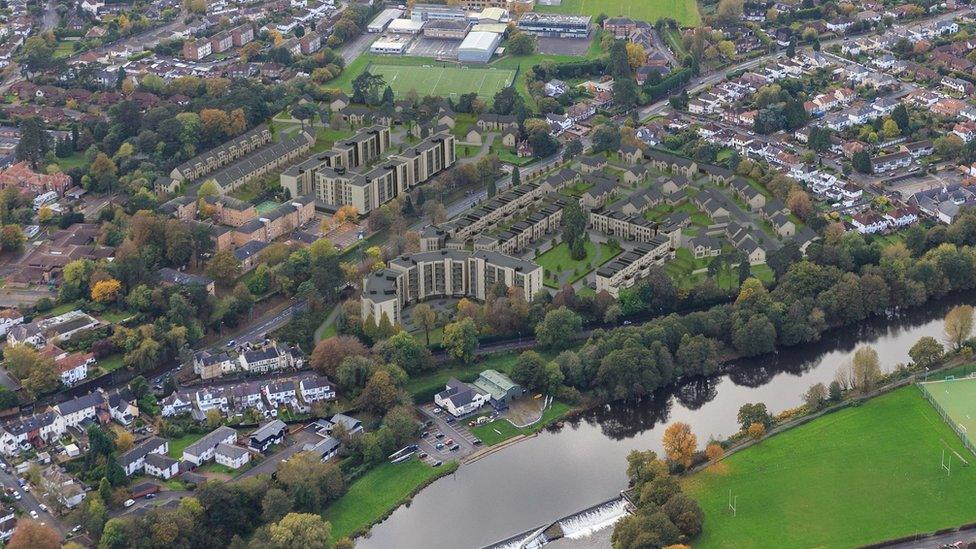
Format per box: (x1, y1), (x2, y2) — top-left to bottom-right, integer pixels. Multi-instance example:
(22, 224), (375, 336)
(685, 387), (976, 548)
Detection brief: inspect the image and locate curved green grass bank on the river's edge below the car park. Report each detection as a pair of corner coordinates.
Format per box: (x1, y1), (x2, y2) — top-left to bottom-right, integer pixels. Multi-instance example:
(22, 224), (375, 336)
(322, 460), (457, 541)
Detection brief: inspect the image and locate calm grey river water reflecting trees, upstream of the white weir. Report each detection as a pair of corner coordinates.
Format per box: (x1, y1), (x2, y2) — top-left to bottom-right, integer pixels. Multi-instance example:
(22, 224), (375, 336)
(356, 293), (976, 549)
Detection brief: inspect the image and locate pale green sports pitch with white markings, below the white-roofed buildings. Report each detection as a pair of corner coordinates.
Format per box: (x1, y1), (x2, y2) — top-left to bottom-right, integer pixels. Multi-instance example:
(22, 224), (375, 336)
(369, 63), (515, 98)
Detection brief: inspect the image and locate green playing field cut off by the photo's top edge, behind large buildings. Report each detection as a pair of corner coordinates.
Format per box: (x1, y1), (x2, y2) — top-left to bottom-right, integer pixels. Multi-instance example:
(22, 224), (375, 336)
(535, 0), (701, 27)
